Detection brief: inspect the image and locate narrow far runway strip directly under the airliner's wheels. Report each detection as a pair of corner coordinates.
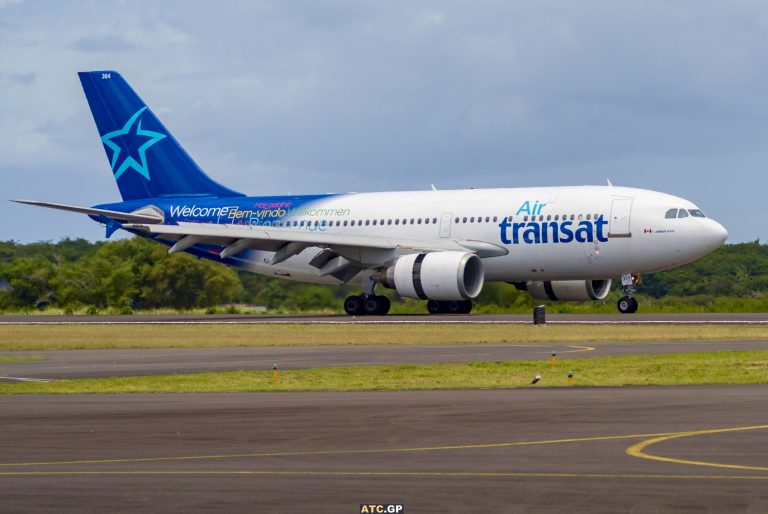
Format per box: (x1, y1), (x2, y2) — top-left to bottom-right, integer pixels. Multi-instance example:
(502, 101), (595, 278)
(0, 313), (768, 325)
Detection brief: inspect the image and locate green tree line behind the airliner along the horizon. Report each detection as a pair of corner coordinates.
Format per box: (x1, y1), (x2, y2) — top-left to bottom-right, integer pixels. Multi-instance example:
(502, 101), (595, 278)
(0, 237), (768, 313)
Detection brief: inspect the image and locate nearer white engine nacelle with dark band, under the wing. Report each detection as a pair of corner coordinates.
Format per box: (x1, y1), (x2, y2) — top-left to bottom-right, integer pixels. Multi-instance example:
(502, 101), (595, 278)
(382, 252), (485, 300)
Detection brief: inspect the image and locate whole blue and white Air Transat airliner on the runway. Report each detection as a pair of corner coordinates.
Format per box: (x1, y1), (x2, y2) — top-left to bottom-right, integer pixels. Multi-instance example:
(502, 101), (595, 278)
(18, 71), (728, 315)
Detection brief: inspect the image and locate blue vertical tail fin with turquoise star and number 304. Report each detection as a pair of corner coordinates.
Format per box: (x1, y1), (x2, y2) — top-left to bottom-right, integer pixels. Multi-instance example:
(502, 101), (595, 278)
(78, 71), (243, 201)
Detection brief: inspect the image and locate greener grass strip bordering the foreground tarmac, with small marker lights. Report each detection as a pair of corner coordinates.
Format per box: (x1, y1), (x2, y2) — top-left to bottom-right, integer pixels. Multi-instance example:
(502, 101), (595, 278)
(6, 350), (768, 394)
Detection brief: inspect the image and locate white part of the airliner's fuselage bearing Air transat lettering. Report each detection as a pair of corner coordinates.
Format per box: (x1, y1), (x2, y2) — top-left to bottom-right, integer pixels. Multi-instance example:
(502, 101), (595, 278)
(241, 186), (727, 283)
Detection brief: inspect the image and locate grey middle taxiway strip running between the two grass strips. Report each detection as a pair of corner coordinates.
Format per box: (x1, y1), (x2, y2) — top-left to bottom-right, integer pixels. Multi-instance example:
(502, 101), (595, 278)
(0, 340), (768, 382)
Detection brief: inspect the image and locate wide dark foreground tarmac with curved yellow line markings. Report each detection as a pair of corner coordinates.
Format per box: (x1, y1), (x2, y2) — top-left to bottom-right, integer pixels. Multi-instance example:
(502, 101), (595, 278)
(0, 385), (768, 513)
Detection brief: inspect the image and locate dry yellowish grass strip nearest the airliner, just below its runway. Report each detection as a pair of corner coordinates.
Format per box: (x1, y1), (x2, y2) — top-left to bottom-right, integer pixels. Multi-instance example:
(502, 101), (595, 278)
(0, 324), (768, 351)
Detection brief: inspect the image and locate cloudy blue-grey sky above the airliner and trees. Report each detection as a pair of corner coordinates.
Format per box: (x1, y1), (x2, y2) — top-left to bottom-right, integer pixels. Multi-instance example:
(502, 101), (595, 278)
(0, 0), (768, 242)
